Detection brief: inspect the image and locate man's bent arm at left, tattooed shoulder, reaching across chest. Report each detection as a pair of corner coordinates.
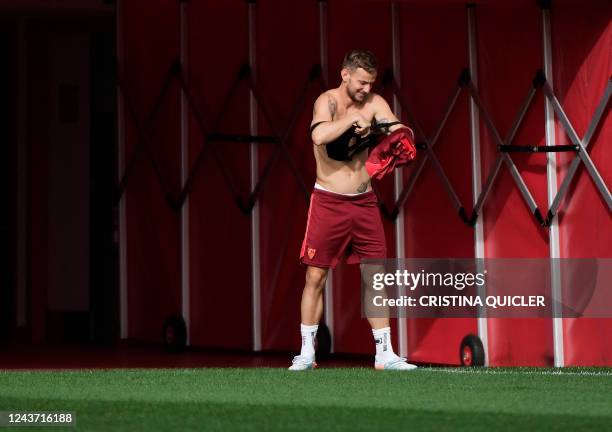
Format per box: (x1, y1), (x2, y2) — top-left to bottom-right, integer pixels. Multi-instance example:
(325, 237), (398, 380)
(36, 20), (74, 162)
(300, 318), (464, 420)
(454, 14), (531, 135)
(310, 93), (370, 146)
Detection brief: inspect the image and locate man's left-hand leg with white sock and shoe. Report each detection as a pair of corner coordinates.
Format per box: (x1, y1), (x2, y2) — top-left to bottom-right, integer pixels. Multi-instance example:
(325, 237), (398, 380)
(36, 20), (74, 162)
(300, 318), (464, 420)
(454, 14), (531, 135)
(289, 266), (328, 370)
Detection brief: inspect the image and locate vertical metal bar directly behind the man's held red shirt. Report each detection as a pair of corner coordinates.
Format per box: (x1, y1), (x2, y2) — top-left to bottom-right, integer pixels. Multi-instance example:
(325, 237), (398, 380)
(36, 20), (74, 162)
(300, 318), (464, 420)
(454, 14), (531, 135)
(391, 2), (408, 358)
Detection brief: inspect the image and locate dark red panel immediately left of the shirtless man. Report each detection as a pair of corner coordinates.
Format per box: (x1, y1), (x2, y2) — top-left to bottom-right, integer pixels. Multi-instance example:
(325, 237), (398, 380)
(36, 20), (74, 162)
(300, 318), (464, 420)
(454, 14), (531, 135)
(257, 0), (321, 350)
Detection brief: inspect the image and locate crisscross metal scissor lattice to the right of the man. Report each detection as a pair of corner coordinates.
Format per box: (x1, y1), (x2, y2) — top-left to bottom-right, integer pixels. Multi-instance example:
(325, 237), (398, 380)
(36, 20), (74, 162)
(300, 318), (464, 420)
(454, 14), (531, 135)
(382, 69), (612, 227)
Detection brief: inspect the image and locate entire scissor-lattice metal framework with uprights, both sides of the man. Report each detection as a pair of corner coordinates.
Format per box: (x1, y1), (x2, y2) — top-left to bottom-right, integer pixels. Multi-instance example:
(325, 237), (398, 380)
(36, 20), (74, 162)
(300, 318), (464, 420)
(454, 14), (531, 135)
(116, 0), (612, 366)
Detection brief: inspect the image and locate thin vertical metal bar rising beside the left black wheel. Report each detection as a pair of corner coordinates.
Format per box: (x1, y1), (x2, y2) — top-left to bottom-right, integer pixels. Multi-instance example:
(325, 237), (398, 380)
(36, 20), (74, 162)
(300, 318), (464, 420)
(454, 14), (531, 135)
(179, 2), (191, 346)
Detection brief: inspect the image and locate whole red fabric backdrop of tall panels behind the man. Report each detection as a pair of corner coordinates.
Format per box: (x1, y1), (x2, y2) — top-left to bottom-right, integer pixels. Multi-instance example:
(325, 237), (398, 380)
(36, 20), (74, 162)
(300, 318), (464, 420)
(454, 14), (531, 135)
(119, 0), (612, 365)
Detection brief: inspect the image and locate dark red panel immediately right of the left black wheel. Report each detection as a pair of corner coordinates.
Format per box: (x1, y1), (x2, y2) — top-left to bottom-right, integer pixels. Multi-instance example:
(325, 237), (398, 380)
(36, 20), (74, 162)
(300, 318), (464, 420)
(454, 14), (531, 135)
(187, 0), (252, 349)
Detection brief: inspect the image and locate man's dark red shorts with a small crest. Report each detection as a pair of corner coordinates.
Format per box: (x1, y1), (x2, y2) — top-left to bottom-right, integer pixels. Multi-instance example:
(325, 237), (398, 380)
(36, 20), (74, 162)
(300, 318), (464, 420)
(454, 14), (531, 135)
(300, 189), (387, 268)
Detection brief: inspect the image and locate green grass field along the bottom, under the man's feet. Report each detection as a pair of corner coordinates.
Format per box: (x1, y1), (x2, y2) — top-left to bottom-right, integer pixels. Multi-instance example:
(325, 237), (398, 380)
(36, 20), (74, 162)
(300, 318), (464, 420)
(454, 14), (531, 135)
(0, 368), (612, 432)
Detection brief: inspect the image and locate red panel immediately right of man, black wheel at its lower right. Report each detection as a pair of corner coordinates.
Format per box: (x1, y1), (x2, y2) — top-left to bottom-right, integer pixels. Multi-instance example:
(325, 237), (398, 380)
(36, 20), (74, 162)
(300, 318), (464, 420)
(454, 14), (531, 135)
(400, 4), (476, 364)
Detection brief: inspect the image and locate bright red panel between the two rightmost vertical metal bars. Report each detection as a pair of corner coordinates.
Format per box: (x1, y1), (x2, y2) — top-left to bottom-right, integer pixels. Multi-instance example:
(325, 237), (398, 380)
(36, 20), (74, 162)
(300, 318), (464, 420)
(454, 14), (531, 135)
(478, 5), (552, 366)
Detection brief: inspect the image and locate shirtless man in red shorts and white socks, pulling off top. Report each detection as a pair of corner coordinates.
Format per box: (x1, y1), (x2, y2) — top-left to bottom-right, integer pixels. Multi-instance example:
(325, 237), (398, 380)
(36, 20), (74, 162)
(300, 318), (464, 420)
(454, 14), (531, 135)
(289, 50), (416, 370)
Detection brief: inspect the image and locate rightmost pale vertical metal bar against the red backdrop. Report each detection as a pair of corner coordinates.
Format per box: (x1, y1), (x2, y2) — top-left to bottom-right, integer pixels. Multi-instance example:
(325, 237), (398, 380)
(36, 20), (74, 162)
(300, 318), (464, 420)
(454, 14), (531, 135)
(542, 8), (565, 367)
